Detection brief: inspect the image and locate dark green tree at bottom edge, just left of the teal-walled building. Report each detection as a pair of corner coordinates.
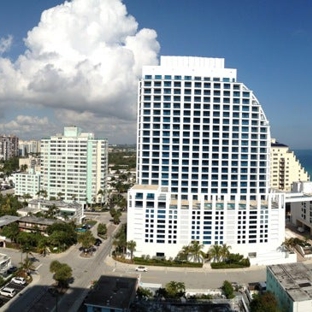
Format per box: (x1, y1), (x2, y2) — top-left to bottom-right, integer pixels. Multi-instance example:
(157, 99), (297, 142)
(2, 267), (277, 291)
(250, 291), (281, 312)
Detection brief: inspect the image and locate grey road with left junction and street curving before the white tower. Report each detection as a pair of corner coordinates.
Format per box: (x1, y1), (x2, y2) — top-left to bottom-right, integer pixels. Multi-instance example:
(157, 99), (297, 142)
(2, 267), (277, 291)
(0, 214), (312, 312)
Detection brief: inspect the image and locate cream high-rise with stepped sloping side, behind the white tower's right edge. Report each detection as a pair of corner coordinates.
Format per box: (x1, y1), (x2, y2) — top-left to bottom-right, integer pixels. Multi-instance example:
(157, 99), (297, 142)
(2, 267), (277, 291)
(270, 139), (310, 192)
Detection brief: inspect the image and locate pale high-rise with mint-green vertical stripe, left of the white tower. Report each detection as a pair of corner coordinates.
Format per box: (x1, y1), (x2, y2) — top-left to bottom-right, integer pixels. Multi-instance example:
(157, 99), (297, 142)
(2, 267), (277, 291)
(41, 126), (108, 204)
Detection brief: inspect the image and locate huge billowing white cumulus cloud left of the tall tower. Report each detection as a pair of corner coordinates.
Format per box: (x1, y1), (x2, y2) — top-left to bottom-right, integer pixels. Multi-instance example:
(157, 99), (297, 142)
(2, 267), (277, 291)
(0, 0), (160, 142)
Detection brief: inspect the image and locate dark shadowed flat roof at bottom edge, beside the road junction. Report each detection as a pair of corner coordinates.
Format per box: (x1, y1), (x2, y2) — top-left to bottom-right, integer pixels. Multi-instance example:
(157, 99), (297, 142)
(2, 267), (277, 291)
(85, 275), (138, 309)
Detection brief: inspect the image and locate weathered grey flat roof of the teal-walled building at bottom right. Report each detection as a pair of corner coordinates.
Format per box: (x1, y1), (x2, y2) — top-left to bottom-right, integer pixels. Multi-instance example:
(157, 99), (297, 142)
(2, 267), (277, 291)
(268, 262), (312, 301)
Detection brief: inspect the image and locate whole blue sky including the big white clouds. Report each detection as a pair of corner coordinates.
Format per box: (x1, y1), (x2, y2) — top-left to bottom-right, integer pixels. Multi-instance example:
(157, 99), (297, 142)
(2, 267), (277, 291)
(0, 0), (312, 149)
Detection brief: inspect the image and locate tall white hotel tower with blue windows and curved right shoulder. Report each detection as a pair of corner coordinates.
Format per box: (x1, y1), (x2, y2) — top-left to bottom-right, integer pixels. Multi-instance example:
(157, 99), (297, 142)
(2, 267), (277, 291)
(127, 56), (287, 263)
